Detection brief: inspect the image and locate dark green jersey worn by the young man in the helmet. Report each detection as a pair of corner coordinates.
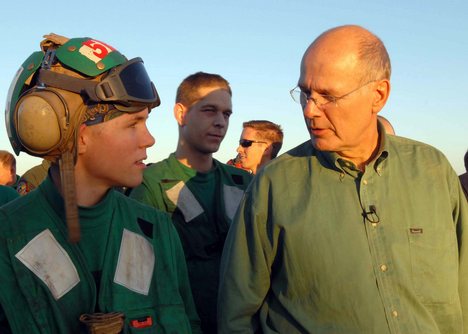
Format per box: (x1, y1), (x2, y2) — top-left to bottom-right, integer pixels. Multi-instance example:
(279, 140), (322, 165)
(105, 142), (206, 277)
(0, 177), (200, 334)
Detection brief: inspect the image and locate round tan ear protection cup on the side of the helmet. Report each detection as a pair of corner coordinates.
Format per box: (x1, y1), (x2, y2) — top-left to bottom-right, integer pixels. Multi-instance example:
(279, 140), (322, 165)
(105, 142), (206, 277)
(15, 88), (70, 156)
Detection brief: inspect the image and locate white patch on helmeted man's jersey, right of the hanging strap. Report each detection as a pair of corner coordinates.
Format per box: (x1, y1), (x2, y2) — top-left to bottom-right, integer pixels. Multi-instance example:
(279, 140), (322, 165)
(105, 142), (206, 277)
(114, 229), (155, 296)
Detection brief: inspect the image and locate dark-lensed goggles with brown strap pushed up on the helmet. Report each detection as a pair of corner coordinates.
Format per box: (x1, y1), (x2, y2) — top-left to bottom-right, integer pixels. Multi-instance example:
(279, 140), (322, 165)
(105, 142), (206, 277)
(38, 58), (161, 112)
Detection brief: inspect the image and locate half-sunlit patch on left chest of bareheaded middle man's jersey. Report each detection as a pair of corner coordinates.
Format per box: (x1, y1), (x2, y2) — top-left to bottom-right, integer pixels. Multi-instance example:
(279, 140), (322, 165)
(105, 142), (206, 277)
(166, 181), (203, 223)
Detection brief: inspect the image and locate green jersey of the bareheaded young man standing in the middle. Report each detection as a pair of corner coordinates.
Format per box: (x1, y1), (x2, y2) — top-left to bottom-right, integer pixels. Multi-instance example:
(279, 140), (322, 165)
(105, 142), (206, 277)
(130, 154), (251, 333)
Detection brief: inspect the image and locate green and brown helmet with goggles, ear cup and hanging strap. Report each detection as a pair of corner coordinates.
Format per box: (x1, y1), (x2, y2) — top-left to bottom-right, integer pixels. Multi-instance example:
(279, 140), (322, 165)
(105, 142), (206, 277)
(5, 34), (160, 242)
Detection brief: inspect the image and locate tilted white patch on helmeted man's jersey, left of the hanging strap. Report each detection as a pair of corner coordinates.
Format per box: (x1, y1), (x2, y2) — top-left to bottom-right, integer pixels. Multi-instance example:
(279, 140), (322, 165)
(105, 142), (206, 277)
(15, 229), (80, 300)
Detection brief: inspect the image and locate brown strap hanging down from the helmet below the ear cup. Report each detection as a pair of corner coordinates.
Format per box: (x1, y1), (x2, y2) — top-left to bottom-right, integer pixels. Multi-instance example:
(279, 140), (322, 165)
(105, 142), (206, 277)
(60, 151), (80, 243)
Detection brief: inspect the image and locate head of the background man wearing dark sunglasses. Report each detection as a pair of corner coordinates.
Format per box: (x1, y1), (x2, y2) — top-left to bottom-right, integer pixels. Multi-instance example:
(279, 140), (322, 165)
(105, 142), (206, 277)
(237, 120), (283, 174)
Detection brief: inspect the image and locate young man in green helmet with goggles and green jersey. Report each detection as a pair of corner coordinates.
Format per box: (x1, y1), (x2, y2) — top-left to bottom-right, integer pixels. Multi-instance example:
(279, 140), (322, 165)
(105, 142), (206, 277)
(0, 34), (200, 334)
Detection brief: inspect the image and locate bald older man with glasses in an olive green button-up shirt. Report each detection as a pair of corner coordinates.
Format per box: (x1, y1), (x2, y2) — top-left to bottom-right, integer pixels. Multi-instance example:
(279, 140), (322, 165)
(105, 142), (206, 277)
(218, 26), (468, 334)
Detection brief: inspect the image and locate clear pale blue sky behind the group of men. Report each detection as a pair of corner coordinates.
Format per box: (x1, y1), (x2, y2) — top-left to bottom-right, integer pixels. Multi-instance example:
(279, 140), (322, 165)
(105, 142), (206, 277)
(0, 0), (468, 174)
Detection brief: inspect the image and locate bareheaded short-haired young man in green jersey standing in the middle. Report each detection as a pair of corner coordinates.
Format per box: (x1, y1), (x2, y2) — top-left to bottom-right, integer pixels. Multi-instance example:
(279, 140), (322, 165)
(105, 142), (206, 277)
(130, 72), (251, 333)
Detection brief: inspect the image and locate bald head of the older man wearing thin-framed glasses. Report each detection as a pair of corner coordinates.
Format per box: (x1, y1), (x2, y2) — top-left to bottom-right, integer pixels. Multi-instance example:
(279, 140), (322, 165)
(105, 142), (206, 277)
(296, 26), (390, 168)
